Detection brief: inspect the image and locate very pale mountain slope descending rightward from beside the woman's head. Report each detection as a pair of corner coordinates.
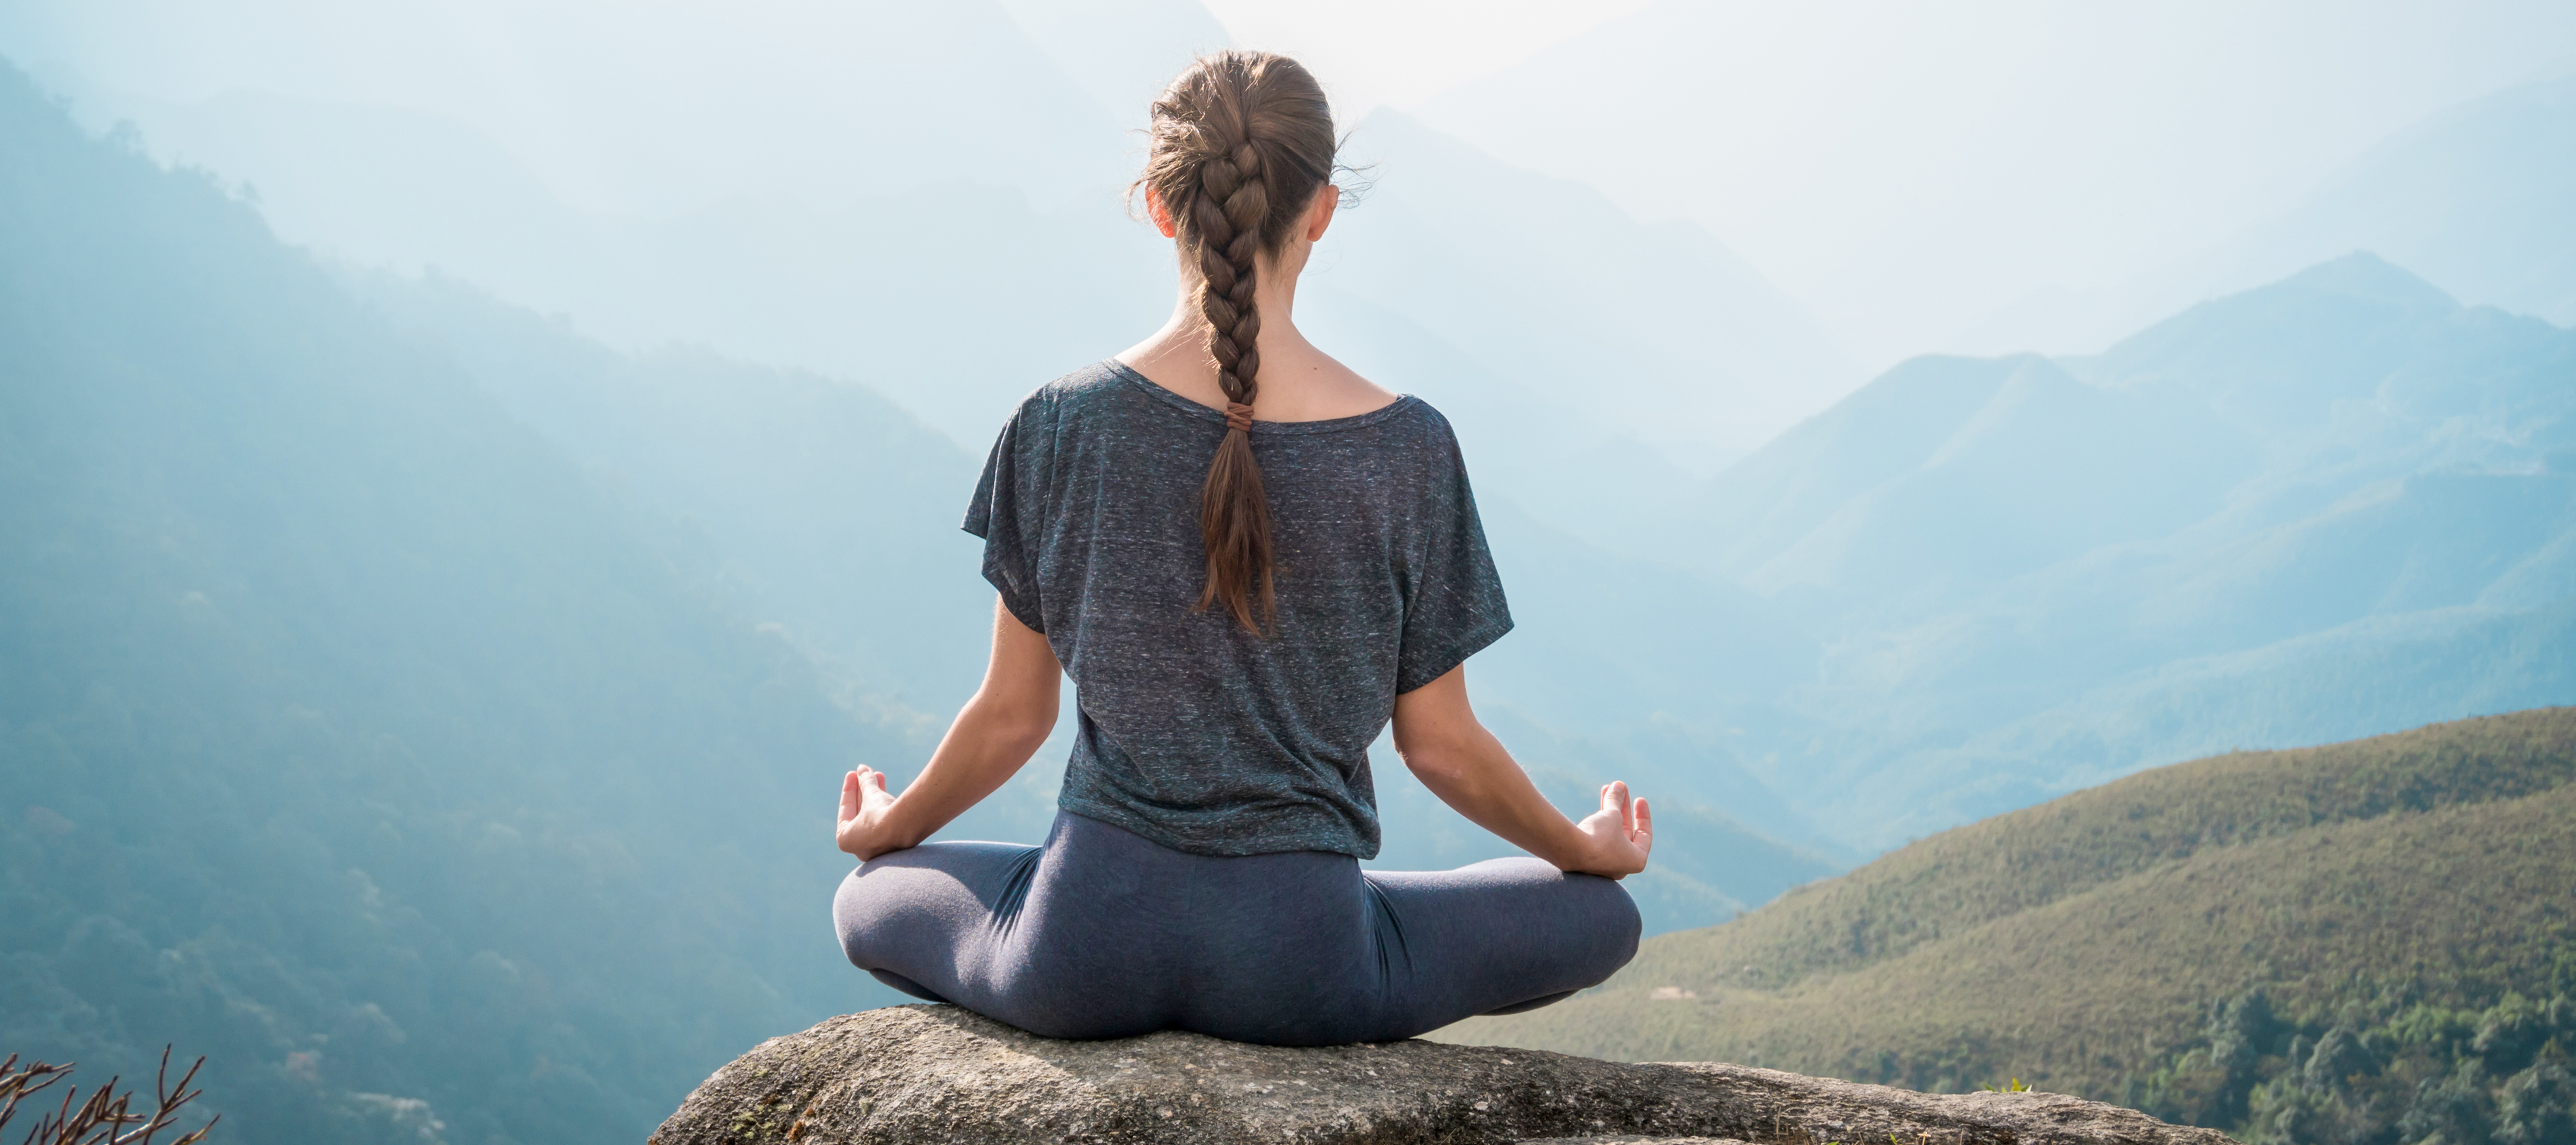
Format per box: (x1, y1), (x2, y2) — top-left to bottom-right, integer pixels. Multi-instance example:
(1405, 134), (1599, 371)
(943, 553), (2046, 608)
(1311, 108), (1860, 472)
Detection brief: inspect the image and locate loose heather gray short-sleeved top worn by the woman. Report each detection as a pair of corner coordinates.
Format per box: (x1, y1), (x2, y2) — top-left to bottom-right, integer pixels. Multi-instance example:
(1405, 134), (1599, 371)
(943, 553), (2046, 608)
(966, 361), (1512, 859)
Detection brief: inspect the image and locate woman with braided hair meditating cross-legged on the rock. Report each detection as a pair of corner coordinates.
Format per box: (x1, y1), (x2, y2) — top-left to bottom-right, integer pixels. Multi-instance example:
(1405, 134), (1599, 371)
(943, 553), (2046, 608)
(832, 51), (1654, 1045)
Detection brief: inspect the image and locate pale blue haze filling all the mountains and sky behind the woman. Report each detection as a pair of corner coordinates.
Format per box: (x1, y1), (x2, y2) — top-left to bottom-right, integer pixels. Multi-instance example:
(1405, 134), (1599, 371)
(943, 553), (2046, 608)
(0, 0), (2576, 1142)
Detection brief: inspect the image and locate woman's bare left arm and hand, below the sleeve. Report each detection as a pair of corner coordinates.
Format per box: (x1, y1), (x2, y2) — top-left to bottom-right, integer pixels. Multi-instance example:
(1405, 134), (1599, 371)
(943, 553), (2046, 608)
(834, 598), (1064, 859)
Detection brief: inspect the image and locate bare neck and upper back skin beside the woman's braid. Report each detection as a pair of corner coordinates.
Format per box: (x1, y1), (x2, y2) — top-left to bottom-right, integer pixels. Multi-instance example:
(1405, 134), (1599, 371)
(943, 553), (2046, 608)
(1118, 258), (1396, 420)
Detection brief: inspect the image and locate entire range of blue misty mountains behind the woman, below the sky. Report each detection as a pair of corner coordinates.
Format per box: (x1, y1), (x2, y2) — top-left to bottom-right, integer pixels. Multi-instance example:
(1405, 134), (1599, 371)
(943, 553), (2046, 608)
(0, 3), (2576, 1142)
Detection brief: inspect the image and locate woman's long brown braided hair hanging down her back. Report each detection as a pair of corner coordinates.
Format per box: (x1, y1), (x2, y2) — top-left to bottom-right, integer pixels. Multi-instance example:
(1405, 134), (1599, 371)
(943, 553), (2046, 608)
(1136, 51), (1334, 635)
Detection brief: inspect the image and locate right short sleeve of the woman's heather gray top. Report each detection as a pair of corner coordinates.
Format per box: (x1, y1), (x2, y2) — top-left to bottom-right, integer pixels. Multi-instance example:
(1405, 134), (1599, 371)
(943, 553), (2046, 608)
(1396, 425), (1512, 694)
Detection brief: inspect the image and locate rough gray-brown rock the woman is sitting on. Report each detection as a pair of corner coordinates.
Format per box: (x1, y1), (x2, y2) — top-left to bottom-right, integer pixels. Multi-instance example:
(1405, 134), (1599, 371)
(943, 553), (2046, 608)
(652, 1006), (2234, 1145)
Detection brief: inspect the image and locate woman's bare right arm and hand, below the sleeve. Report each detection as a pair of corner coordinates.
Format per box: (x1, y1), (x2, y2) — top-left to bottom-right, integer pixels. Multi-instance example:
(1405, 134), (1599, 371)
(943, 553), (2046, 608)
(1396, 666), (1654, 879)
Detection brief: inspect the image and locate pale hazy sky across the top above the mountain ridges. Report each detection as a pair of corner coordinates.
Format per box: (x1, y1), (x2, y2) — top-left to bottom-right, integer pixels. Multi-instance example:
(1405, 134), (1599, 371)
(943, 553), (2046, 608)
(0, 0), (2576, 379)
